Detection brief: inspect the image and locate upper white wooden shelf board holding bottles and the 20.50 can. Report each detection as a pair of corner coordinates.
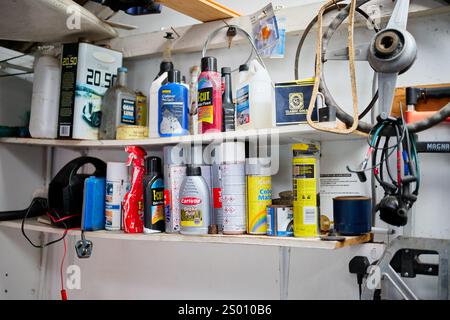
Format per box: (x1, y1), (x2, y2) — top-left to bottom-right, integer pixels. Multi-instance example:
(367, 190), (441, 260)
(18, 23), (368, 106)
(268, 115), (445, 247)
(0, 123), (366, 148)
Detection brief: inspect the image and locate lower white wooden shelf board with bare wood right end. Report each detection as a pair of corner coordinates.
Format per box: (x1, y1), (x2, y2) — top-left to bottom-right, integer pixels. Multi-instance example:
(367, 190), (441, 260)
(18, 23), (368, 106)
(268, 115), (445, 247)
(0, 218), (372, 250)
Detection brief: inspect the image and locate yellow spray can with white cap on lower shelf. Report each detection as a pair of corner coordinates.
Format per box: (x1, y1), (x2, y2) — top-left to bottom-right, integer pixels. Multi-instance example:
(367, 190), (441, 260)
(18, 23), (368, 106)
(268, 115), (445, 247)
(245, 158), (272, 234)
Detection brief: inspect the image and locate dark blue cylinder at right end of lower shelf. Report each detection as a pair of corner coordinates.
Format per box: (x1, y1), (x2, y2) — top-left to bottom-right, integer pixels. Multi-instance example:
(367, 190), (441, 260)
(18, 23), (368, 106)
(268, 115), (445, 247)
(333, 196), (372, 236)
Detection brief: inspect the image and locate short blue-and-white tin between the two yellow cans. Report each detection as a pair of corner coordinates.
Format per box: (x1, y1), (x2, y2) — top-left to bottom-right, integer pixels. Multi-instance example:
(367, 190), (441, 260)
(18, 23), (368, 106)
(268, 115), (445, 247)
(267, 205), (294, 237)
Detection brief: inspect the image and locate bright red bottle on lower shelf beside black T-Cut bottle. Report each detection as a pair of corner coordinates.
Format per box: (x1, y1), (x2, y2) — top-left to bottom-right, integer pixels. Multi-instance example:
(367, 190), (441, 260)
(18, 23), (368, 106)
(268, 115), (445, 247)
(122, 146), (147, 233)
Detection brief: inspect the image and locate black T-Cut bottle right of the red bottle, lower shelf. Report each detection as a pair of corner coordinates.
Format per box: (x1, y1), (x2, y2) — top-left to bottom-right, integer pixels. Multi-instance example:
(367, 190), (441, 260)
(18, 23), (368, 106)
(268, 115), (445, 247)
(143, 157), (165, 233)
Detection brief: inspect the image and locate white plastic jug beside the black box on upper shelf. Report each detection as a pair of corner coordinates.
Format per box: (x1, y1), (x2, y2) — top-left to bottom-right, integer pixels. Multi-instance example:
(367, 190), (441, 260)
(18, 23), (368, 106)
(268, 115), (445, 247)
(236, 60), (275, 130)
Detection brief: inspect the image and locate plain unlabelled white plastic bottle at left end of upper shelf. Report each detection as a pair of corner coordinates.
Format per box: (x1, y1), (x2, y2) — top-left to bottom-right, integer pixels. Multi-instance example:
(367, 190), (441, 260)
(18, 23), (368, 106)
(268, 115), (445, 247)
(29, 51), (61, 139)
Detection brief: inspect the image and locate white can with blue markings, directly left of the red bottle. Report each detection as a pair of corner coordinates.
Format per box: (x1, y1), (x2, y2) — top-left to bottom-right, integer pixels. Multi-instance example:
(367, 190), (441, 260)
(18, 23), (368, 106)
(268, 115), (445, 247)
(105, 162), (129, 231)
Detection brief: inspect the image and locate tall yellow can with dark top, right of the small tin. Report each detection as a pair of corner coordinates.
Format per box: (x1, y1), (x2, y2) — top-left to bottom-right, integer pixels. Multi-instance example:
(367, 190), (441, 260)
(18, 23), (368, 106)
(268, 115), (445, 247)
(292, 143), (320, 237)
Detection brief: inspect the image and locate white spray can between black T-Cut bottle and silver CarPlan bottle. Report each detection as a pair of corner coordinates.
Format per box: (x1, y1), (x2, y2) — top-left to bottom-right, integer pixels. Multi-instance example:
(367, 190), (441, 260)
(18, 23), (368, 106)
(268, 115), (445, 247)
(163, 146), (186, 233)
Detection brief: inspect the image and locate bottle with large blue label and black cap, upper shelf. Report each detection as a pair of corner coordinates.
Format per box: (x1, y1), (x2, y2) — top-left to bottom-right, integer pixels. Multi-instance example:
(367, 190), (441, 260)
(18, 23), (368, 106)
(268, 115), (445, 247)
(158, 70), (189, 137)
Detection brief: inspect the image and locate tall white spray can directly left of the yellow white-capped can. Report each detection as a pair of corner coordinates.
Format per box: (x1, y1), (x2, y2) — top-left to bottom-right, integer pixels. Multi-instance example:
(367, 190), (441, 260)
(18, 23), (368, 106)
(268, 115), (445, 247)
(219, 142), (246, 234)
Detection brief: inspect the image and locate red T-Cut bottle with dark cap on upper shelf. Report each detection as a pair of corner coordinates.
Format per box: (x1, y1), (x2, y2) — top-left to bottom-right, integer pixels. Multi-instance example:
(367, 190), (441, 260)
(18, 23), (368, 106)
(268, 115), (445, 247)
(197, 57), (222, 133)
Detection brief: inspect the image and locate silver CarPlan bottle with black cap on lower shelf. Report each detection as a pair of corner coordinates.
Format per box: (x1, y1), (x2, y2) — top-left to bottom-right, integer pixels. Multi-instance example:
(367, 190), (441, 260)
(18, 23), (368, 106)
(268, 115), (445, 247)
(180, 167), (211, 234)
